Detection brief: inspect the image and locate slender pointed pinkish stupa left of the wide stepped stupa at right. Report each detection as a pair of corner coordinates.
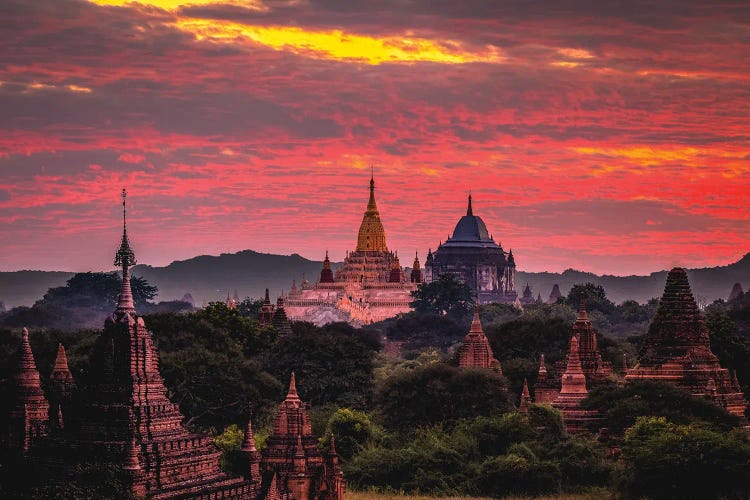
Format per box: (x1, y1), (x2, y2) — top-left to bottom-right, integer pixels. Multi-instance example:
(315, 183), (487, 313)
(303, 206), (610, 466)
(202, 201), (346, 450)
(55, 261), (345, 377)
(552, 335), (597, 434)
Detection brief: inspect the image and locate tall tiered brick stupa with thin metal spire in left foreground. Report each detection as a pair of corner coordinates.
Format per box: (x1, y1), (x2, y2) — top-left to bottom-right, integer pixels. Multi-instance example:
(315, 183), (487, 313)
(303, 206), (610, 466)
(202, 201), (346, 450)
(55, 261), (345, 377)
(34, 190), (260, 499)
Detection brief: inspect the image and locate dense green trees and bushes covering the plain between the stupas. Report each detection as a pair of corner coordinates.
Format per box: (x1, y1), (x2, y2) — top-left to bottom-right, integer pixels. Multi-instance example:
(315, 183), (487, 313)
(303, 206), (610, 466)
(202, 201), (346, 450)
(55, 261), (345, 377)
(0, 273), (750, 498)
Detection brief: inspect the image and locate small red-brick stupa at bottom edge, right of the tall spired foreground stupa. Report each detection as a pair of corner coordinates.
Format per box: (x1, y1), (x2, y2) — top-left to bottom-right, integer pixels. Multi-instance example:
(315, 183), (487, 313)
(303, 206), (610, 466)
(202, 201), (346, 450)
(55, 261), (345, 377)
(262, 373), (345, 500)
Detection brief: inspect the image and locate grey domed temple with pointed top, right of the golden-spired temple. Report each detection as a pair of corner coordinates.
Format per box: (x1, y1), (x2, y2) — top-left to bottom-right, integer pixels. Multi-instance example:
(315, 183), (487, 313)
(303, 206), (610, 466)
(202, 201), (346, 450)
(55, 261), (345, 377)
(425, 195), (518, 304)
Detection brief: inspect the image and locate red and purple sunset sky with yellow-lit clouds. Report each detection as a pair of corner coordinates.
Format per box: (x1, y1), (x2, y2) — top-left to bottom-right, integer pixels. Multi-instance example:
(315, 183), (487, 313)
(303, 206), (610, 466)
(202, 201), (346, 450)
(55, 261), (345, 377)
(0, 0), (750, 275)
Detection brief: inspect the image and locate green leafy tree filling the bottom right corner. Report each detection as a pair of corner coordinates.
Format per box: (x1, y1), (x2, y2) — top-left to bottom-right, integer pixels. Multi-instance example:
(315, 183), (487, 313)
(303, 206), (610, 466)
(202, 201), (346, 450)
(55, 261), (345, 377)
(620, 417), (750, 500)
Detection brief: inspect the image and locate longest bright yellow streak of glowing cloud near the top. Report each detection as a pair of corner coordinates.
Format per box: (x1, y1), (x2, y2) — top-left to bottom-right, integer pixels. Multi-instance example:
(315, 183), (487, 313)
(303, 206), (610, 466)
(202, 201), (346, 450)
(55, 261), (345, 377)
(173, 19), (503, 64)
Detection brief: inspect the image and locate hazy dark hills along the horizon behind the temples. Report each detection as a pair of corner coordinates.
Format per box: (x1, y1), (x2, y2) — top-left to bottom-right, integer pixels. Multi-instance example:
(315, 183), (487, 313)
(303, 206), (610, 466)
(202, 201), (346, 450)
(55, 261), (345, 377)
(0, 250), (750, 308)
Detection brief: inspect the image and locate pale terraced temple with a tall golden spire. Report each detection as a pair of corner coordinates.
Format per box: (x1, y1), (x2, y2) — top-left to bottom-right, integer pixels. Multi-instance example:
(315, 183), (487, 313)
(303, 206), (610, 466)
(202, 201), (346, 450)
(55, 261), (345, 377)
(286, 178), (422, 326)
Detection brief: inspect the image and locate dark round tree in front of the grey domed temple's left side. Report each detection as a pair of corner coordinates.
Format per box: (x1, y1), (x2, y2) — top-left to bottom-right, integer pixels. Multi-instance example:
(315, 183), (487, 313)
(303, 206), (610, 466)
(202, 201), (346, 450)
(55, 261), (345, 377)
(410, 273), (474, 317)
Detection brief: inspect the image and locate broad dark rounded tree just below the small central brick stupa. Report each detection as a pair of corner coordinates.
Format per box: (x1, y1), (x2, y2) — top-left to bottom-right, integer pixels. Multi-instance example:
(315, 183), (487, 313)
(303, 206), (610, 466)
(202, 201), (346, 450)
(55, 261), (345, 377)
(375, 363), (513, 431)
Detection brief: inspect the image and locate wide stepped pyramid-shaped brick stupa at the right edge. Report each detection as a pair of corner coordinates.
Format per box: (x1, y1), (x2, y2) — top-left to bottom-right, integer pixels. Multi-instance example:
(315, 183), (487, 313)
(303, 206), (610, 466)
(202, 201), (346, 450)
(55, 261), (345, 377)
(625, 267), (747, 417)
